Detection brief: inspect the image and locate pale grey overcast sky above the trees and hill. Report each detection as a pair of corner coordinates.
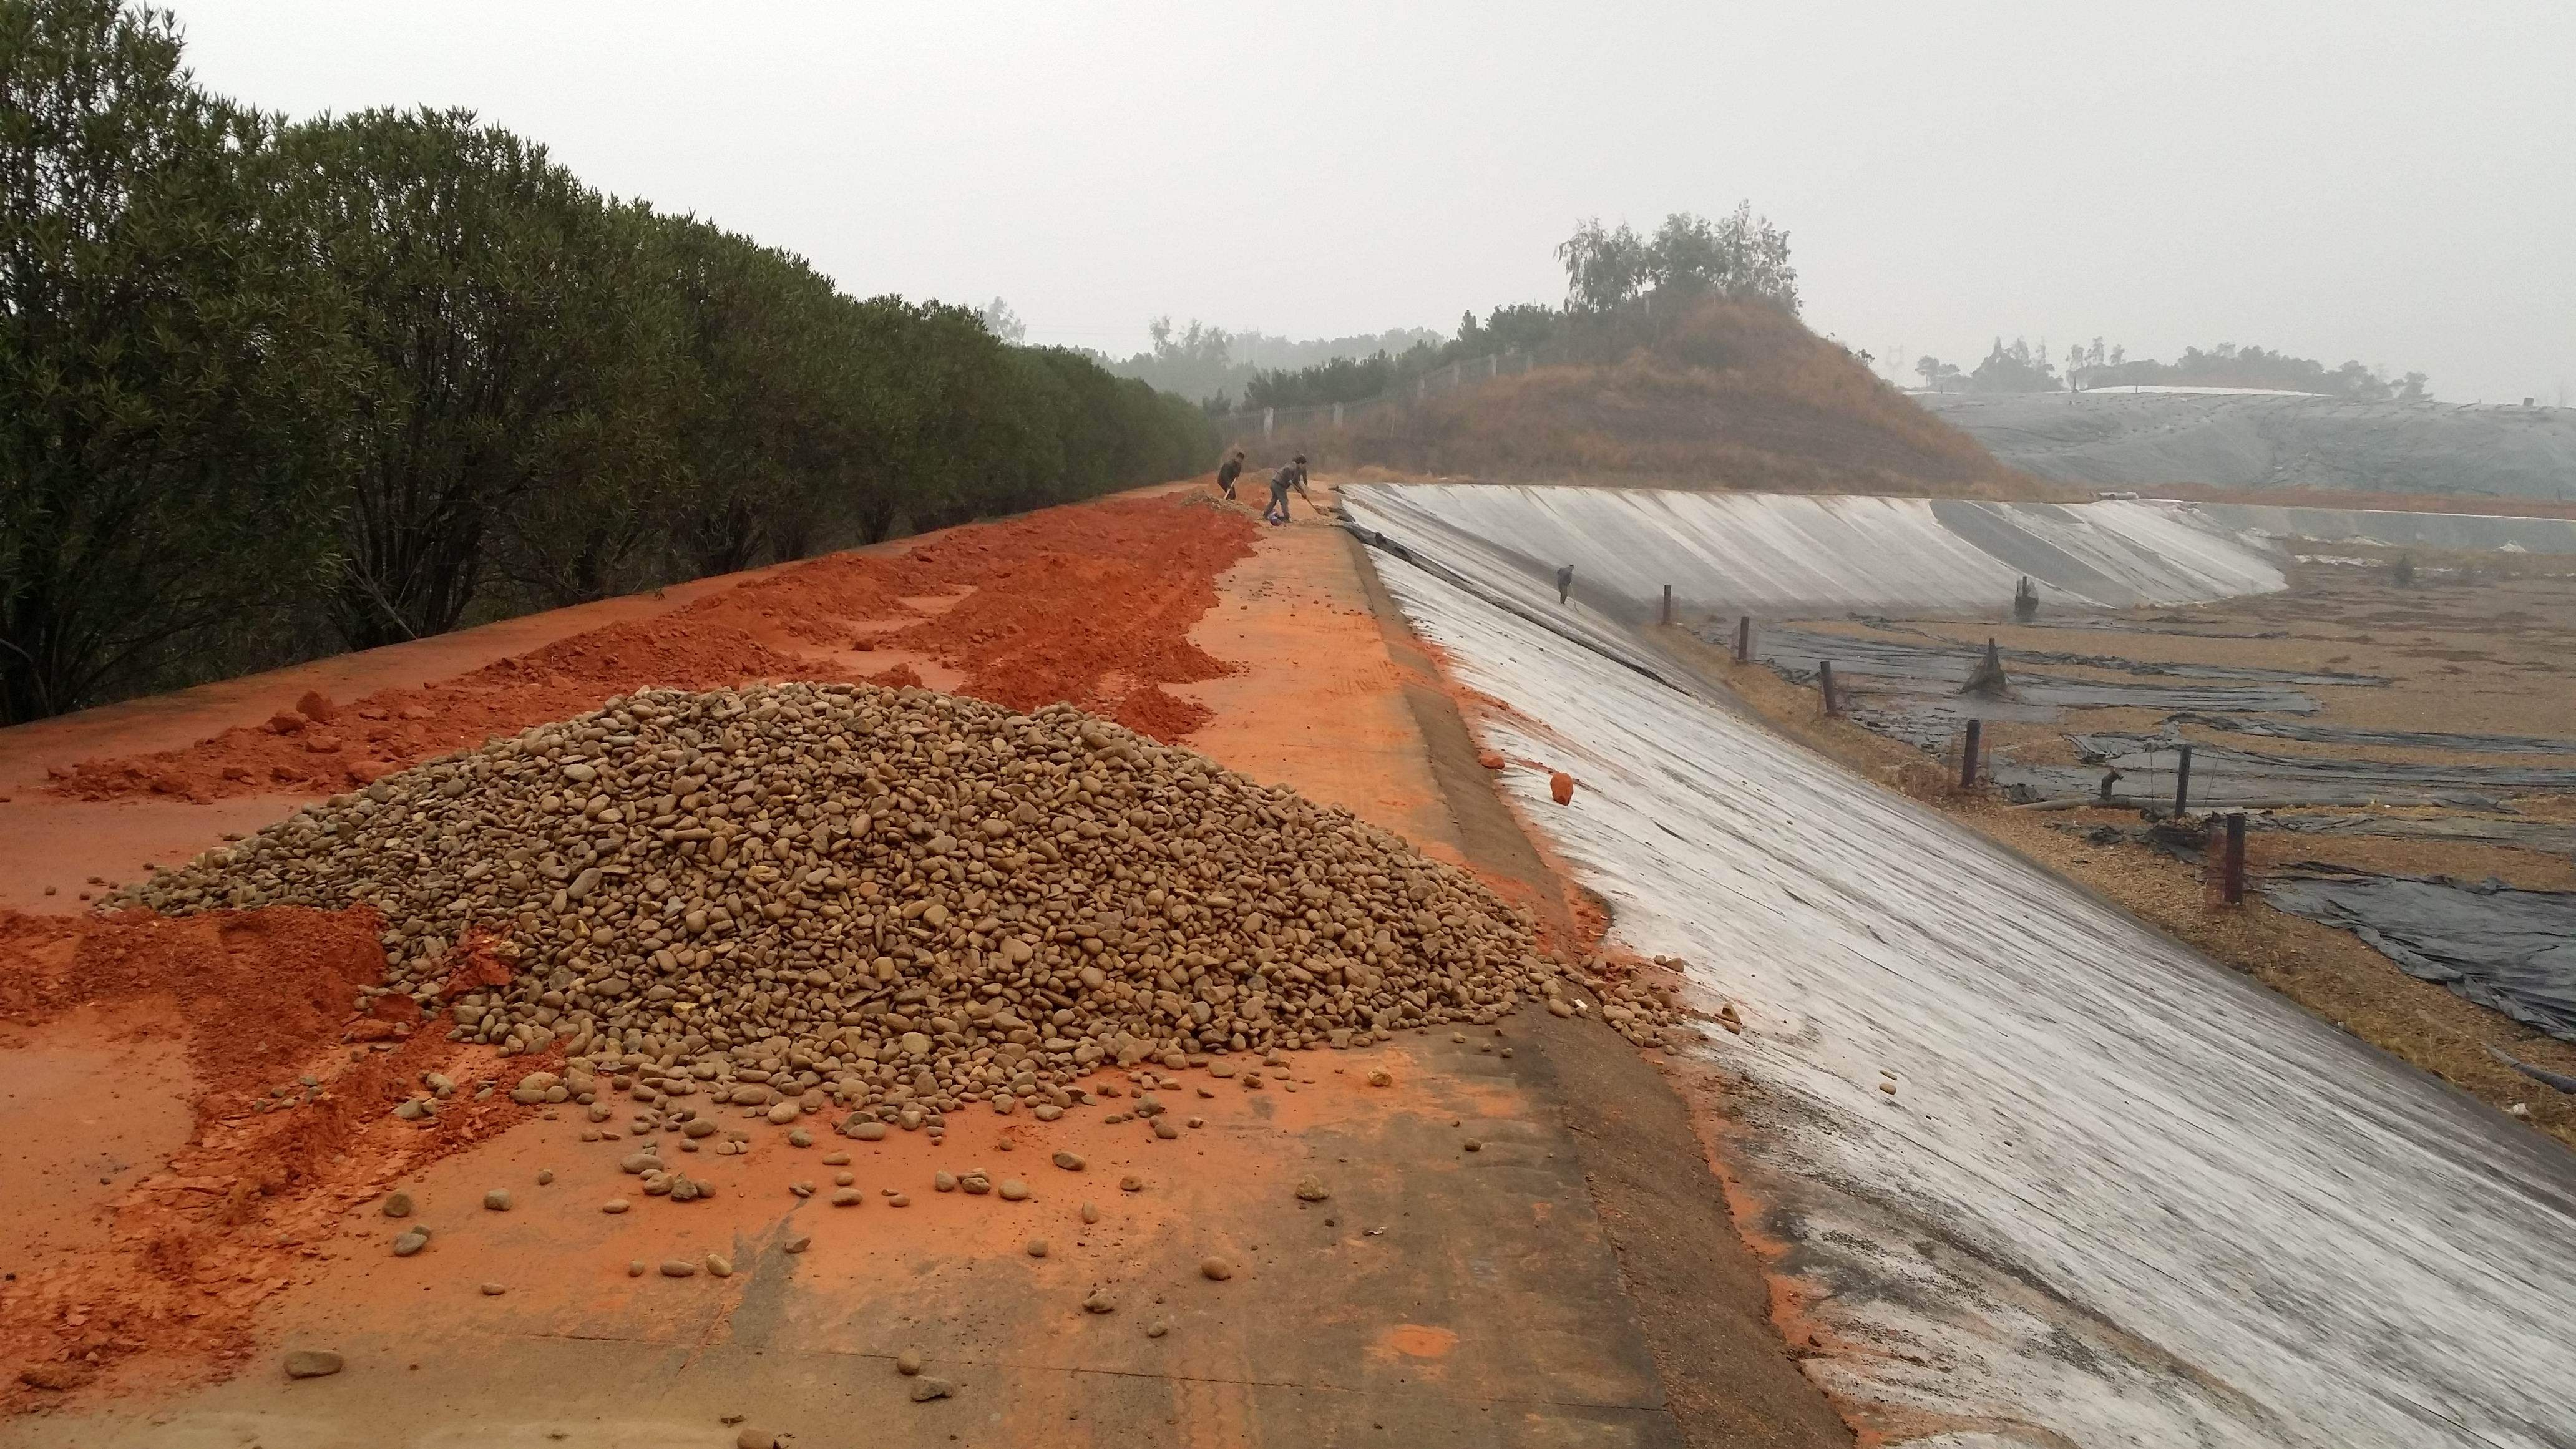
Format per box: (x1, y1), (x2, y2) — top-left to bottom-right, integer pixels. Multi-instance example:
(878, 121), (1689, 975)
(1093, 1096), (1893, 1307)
(175, 0), (2576, 402)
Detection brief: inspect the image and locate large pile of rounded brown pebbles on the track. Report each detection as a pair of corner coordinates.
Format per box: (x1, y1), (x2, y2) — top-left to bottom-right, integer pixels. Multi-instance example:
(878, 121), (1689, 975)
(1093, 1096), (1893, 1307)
(114, 683), (1571, 1114)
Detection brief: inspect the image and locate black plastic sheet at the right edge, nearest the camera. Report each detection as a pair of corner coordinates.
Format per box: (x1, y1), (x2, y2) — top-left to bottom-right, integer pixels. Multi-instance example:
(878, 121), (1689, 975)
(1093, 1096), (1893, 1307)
(2256, 866), (2576, 1042)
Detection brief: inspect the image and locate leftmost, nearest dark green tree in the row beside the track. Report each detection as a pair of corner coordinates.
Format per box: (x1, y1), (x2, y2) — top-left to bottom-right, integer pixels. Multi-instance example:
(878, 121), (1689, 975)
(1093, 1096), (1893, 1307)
(0, 0), (345, 722)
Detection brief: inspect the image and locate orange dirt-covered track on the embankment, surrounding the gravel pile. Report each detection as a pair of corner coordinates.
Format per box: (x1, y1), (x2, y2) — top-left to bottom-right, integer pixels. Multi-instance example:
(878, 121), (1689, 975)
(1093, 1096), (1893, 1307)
(0, 490), (1852, 1449)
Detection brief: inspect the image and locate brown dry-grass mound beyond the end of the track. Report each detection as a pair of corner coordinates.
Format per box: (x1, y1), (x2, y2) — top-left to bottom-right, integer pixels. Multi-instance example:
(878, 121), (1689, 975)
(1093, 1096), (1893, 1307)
(1314, 299), (2040, 497)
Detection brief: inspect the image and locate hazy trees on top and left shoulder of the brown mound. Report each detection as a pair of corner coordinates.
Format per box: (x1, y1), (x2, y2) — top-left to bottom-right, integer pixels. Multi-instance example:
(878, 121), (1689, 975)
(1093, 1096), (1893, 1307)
(1211, 203), (1798, 410)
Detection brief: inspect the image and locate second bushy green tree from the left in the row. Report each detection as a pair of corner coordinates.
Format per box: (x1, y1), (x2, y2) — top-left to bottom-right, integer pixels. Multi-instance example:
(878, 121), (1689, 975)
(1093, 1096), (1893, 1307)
(286, 111), (631, 650)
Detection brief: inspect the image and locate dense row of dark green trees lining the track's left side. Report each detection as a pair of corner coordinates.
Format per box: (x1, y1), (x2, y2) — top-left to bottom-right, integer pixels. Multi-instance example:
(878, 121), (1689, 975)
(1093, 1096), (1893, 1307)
(0, 0), (1213, 722)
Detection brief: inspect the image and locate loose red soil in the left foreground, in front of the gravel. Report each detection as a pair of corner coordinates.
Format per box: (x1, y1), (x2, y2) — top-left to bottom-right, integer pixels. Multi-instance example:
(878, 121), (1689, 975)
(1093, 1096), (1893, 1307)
(0, 907), (539, 1410)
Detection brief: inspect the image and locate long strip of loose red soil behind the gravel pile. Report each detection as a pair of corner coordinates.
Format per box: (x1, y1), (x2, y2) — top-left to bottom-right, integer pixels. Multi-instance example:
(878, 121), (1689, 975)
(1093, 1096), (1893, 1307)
(52, 497), (1254, 802)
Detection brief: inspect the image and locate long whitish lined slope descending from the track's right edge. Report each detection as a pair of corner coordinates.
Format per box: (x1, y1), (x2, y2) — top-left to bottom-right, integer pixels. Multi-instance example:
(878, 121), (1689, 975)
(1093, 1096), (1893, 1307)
(1381, 554), (2576, 1449)
